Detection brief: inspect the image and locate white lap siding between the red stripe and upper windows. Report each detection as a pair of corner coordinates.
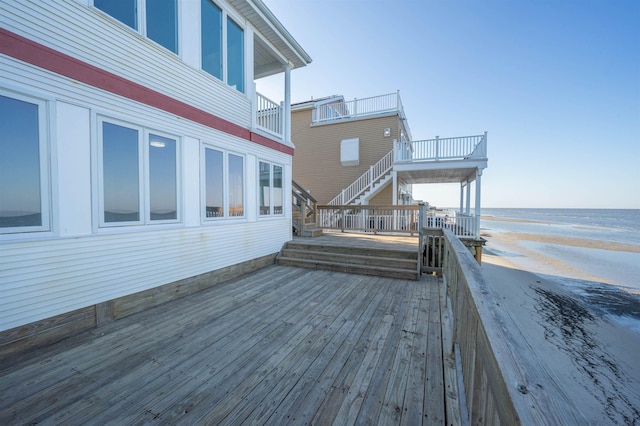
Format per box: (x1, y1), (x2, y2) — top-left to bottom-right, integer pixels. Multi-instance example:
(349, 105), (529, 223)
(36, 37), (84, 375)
(0, 0), (251, 128)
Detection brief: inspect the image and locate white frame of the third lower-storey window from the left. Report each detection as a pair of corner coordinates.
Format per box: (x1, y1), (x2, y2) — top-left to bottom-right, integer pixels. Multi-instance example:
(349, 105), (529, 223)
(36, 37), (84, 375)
(200, 142), (247, 224)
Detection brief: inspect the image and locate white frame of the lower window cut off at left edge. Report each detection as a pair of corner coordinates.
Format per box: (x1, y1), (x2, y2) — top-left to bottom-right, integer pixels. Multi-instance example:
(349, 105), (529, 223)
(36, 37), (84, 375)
(0, 88), (51, 234)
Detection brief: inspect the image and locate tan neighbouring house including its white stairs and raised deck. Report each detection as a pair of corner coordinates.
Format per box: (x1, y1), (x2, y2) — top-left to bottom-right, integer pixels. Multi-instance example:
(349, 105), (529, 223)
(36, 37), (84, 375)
(291, 93), (488, 240)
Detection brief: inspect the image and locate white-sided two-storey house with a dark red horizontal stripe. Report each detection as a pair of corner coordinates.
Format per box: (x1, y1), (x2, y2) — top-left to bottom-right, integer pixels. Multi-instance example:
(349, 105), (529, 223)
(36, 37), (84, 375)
(0, 0), (311, 355)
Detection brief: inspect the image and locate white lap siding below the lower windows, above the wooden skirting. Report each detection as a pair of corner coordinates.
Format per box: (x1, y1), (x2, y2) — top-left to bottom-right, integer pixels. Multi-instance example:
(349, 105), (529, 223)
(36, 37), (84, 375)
(0, 220), (291, 331)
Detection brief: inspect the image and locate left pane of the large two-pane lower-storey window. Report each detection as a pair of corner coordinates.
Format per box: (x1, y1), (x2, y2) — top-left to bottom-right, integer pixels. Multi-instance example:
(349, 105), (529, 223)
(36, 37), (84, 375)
(102, 122), (140, 222)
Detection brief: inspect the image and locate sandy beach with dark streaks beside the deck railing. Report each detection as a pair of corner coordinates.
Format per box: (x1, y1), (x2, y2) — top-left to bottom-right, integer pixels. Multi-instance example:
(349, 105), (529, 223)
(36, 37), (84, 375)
(482, 228), (640, 425)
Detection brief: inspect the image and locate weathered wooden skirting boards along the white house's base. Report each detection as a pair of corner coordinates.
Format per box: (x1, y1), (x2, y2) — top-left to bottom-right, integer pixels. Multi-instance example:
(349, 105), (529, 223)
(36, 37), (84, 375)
(0, 253), (277, 363)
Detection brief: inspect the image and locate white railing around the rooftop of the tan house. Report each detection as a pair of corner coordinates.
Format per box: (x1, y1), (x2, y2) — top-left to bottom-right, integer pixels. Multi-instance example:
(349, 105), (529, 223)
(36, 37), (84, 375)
(311, 92), (404, 123)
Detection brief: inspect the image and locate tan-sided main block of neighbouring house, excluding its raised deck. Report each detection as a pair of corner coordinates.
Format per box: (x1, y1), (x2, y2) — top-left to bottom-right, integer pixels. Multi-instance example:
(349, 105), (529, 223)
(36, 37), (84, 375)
(291, 93), (412, 205)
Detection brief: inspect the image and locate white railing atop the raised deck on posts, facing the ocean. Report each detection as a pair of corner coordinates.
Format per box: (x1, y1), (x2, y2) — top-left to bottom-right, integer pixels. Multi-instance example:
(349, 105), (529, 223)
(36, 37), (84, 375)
(396, 132), (487, 161)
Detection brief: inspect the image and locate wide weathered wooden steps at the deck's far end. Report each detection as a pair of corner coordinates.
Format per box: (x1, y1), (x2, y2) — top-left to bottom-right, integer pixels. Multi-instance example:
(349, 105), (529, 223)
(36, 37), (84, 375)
(276, 239), (420, 280)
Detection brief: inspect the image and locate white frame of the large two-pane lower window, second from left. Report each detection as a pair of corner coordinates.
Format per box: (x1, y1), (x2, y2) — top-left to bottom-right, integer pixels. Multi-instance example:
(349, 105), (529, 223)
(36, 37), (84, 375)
(95, 115), (182, 228)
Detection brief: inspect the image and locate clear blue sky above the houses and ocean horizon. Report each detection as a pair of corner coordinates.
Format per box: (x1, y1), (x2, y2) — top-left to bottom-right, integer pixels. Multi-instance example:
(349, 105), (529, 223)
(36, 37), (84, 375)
(257, 0), (640, 209)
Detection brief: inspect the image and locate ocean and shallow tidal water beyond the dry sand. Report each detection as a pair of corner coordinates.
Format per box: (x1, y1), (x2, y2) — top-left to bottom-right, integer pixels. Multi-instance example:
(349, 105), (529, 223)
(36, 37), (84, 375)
(481, 209), (640, 332)
